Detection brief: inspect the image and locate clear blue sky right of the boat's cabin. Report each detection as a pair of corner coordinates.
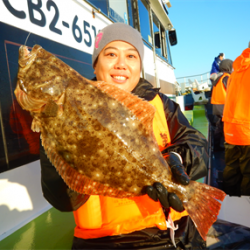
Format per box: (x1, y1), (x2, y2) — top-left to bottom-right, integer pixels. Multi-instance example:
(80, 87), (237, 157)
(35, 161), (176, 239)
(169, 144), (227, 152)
(168, 0), (250, 77)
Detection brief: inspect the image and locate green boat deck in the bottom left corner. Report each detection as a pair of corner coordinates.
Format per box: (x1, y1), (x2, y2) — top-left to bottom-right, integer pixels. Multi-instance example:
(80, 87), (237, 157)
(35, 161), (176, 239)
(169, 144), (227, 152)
(0, 208), (75, 250)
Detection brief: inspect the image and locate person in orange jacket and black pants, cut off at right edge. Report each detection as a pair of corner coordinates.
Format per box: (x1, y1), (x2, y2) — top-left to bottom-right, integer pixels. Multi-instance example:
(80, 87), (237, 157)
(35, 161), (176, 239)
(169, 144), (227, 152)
(222, 43), (250, 196)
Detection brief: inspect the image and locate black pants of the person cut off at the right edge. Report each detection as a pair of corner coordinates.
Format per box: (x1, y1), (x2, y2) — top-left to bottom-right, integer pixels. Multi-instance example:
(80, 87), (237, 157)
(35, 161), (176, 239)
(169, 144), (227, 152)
(223, 143), (250, 196)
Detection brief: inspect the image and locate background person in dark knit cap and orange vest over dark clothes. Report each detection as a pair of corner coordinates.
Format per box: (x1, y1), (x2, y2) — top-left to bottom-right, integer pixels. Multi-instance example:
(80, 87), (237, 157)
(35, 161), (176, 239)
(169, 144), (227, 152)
(211, 59), (233, 151)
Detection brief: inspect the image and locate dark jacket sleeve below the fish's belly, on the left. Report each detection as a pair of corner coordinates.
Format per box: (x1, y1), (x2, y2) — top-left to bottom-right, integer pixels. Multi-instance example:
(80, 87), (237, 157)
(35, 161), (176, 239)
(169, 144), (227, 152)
(40, 141), (89, 212)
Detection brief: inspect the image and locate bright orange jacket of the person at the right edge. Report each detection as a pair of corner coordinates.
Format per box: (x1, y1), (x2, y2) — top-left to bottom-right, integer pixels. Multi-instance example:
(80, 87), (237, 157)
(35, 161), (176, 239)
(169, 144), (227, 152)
(223, 48), (250, 145)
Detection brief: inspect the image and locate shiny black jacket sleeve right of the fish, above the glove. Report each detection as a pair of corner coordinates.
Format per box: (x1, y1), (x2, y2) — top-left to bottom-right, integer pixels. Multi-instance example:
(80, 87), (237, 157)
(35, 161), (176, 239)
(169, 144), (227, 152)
(160, 93), (208, 180)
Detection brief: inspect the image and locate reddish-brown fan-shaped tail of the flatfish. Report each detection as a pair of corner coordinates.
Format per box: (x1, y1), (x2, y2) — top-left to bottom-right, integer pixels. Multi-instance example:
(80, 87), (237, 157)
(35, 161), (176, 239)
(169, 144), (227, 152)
(183, 181), (226, 240)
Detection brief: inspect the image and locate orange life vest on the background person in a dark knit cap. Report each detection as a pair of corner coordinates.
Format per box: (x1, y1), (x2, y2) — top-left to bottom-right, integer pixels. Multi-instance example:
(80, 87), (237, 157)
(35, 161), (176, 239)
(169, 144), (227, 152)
(211, 73), (230, 104)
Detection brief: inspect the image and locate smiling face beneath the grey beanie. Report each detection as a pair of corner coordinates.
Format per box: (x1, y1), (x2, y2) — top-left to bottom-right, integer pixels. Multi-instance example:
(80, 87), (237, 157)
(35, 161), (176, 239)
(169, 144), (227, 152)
(94, 41), (141, 91)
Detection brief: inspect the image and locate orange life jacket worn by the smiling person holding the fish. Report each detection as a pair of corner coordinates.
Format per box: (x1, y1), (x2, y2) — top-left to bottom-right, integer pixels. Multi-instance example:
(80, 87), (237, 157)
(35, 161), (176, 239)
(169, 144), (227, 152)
(74, 95), (188, 239)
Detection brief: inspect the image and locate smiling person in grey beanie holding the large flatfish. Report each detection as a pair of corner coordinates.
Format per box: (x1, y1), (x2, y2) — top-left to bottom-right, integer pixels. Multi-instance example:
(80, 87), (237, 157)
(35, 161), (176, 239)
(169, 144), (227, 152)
(40, 23), (208, 250)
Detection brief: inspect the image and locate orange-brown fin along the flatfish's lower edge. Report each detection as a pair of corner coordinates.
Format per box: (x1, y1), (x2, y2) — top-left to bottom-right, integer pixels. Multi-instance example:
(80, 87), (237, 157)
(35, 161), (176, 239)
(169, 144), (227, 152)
(41, 136), (134, 198)
